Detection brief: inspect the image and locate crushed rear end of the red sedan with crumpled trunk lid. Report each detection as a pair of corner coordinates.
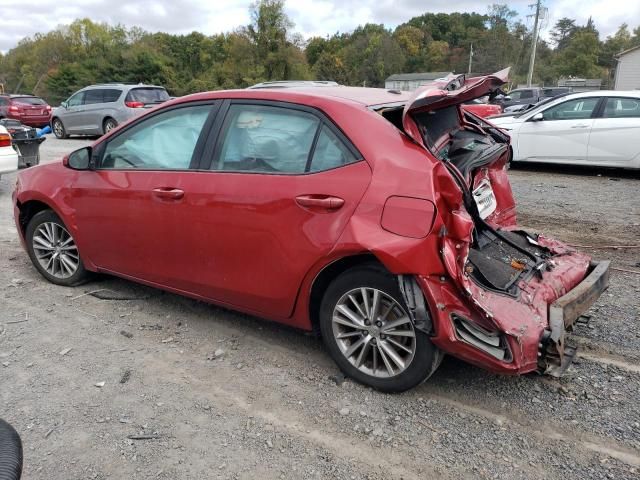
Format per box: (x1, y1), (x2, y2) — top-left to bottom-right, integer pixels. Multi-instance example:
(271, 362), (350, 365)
(401, 71), (609, 376)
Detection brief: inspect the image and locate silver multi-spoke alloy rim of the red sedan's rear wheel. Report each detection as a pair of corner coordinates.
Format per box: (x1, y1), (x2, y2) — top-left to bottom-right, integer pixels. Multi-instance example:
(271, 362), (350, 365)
(331, 288), (416, 378)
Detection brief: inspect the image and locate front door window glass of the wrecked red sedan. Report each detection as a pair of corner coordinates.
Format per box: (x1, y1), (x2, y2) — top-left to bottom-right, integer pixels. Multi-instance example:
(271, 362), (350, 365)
(101, 105), (211, 170)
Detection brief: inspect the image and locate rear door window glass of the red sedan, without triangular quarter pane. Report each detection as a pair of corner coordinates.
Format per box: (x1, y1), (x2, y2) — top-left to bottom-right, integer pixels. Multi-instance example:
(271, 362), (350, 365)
(211, 105), (320, 173)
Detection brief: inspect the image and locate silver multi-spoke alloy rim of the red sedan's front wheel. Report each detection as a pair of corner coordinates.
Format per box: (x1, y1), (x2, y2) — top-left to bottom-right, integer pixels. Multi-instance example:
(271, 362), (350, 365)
(32, 222), (80, 279)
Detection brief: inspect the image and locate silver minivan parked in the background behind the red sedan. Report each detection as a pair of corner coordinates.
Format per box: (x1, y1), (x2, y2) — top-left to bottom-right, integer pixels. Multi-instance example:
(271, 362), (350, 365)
(51, 83), (170, 138)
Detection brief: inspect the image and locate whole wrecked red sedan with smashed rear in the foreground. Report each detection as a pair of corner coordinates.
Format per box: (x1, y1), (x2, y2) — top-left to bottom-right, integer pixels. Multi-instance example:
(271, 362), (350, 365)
(13, 72), (608, 392)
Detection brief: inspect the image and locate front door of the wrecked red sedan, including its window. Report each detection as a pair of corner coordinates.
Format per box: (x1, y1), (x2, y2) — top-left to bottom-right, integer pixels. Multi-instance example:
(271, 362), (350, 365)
(70, 104), (214, 286)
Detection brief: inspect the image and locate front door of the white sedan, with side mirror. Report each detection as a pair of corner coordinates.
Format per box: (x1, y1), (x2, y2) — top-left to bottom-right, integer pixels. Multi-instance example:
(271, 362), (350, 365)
(515, 97), (600, 163)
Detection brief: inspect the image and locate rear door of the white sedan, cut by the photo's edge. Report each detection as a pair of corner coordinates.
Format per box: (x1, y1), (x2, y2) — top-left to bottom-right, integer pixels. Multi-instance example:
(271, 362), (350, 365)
(588, 97), (640, 168)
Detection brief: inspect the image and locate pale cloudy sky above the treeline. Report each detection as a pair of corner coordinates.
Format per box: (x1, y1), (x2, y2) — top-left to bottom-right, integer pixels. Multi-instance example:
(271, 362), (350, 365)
(0, 0), (640, 52)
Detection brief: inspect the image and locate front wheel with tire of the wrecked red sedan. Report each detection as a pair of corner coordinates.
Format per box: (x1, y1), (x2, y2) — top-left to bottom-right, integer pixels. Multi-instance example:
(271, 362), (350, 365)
(25, 210), (89, 287)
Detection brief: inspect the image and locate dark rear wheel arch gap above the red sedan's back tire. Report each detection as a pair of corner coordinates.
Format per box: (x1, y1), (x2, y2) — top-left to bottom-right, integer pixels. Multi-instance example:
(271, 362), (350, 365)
(308, 252), (390, 336)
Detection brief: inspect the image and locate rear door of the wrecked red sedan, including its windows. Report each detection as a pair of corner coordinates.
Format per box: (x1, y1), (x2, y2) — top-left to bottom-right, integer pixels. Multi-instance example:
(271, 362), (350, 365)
(174, 100), (371, 318)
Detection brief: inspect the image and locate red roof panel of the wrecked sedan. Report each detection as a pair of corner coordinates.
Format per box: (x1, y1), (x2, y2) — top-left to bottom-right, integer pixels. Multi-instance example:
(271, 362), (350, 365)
(174, 86), (412, 107)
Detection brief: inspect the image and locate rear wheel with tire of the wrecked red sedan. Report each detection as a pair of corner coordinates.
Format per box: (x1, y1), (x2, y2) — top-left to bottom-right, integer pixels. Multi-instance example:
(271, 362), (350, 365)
(320, 264), (443, 393)
